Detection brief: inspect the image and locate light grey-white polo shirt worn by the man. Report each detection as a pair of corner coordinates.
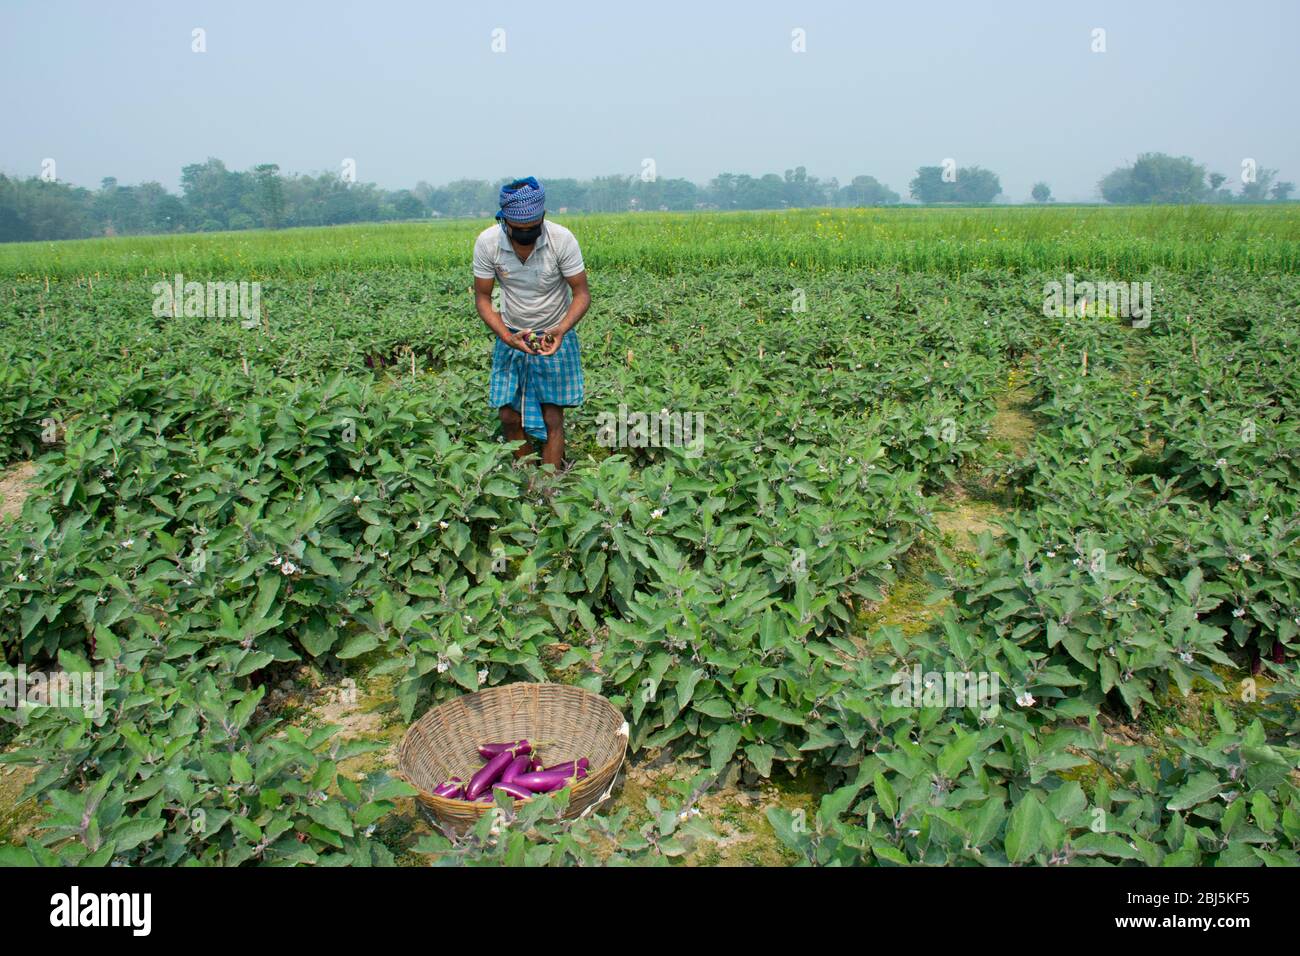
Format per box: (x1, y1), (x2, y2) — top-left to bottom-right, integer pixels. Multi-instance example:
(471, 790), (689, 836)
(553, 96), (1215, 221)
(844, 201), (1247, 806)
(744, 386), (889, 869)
(475, 220), (586, 332)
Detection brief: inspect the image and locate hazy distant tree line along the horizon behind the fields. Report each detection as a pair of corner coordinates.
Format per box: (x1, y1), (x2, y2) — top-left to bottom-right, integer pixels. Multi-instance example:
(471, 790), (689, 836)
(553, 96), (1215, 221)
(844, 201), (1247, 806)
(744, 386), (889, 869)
(0, 153), (1295, 242)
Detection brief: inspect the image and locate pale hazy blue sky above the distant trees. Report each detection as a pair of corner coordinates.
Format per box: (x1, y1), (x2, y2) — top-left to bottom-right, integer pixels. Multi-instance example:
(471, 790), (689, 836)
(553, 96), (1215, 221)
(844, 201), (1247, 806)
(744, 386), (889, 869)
(0, 0), (1300, 200)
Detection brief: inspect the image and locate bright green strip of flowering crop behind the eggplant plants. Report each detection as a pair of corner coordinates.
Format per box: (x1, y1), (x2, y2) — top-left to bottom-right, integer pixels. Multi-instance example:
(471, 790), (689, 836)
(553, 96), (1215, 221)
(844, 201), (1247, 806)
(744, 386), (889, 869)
(0, 206), (1300, 278)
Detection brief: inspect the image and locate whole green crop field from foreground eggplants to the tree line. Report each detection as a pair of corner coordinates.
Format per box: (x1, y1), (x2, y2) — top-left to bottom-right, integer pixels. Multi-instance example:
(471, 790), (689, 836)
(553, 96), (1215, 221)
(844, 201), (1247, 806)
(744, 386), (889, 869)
(0, 204), (1300, 865)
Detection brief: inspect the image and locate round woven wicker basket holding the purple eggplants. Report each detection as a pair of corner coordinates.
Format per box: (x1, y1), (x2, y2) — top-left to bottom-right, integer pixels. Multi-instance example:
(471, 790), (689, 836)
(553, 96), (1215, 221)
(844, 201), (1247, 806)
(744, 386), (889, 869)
(398, 684), (628, 834)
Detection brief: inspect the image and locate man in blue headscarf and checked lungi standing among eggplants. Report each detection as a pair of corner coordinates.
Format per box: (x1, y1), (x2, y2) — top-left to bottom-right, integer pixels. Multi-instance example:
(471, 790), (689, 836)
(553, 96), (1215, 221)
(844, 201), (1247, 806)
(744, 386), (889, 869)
(475, 177), (592, 468)
